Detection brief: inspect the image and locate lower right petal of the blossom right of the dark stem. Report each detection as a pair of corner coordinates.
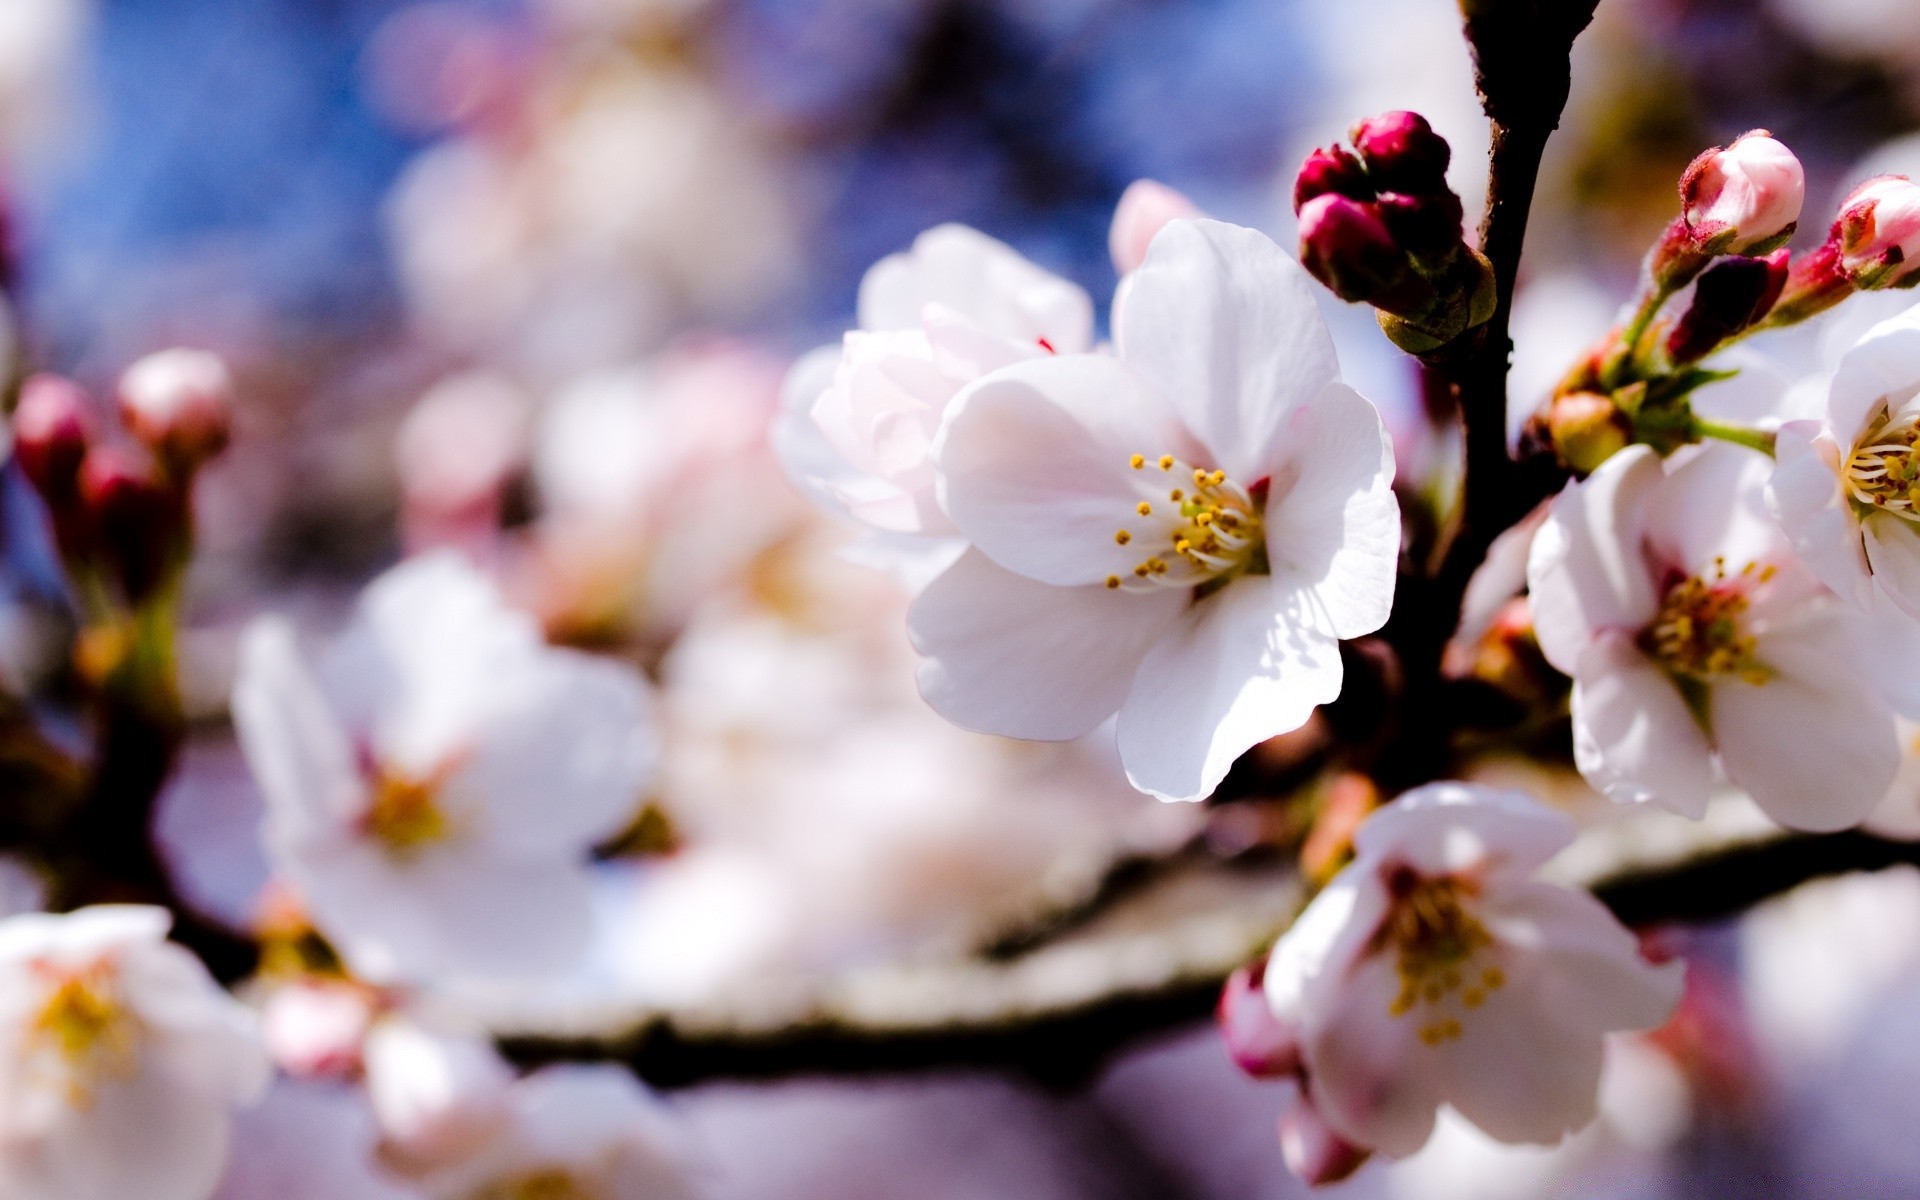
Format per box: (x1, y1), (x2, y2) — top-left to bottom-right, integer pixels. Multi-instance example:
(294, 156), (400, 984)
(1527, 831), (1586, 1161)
(1711, 618), (1901, 831)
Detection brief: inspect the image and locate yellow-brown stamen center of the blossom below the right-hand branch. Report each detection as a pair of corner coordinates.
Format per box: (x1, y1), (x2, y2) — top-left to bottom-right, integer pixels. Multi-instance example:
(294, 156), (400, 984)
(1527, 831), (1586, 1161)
(1375, 866), (1507, 1046)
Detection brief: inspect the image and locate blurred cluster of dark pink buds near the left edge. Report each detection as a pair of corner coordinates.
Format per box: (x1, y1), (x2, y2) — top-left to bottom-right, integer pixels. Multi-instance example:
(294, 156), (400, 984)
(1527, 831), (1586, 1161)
(13, 349), (232, 609)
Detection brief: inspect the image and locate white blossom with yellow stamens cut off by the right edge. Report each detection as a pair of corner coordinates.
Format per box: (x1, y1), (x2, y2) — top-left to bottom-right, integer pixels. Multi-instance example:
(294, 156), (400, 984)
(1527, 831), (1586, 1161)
(1766, 307), (1920, 620)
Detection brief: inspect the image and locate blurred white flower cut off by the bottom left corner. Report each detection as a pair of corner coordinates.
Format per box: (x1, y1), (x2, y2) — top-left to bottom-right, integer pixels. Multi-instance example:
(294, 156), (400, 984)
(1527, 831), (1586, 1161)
(0, 904), (269, 1200)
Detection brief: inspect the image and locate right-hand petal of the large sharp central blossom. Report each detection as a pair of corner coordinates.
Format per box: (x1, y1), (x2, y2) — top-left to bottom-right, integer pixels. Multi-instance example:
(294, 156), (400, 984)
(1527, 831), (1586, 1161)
(1265, 384), (1400, 637)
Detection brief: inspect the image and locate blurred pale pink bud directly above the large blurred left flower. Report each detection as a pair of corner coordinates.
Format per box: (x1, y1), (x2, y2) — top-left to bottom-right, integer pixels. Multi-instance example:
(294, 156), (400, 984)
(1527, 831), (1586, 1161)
(394, 371), (532, 549)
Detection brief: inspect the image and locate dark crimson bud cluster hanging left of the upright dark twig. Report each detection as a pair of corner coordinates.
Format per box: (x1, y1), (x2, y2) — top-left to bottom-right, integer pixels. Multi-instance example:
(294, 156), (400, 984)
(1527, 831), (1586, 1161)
(1294, 113), (1494, 353)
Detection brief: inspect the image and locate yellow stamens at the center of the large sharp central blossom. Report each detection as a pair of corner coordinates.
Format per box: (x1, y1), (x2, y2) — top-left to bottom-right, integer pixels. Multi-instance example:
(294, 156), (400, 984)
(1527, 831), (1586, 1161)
(1106, 455), (1267, 591)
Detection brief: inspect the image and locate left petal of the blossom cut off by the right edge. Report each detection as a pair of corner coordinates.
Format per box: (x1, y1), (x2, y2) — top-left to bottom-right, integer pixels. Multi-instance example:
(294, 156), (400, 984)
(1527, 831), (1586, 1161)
(1766, 420), (1873, 609)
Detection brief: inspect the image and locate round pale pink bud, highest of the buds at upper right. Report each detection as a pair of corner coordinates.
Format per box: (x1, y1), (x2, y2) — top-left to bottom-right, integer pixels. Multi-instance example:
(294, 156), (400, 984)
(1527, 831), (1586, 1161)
(1680, 129), (1807, 253)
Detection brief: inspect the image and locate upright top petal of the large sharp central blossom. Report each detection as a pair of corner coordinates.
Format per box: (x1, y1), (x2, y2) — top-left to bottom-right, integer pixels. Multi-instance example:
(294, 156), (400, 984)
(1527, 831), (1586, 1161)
(1114, 219), (1340, 484)
